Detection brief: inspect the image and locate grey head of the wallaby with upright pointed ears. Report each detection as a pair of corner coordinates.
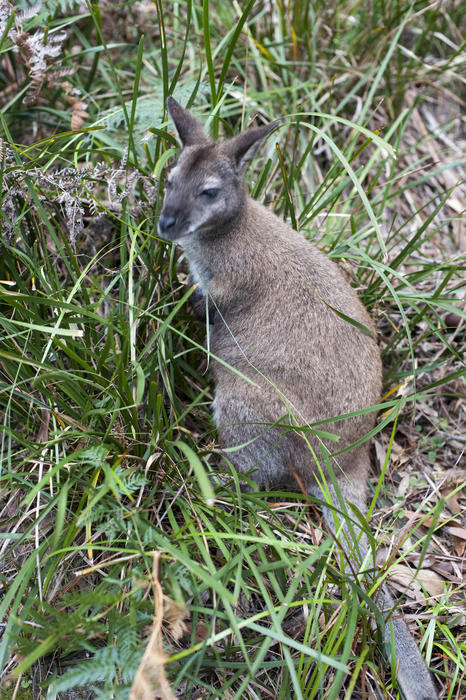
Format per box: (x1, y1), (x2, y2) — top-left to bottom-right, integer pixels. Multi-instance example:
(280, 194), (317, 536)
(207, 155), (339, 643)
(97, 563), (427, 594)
(158, 97), (277, 241)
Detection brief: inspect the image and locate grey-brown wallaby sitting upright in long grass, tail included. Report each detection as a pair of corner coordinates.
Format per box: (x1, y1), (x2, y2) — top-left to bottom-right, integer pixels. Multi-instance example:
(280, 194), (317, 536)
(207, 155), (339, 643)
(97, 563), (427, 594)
(158, 97), (437, 700)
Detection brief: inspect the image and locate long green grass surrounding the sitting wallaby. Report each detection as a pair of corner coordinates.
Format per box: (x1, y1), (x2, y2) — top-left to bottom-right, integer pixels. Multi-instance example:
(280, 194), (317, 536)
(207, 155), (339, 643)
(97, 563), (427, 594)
(0, 0), (466, 700)
